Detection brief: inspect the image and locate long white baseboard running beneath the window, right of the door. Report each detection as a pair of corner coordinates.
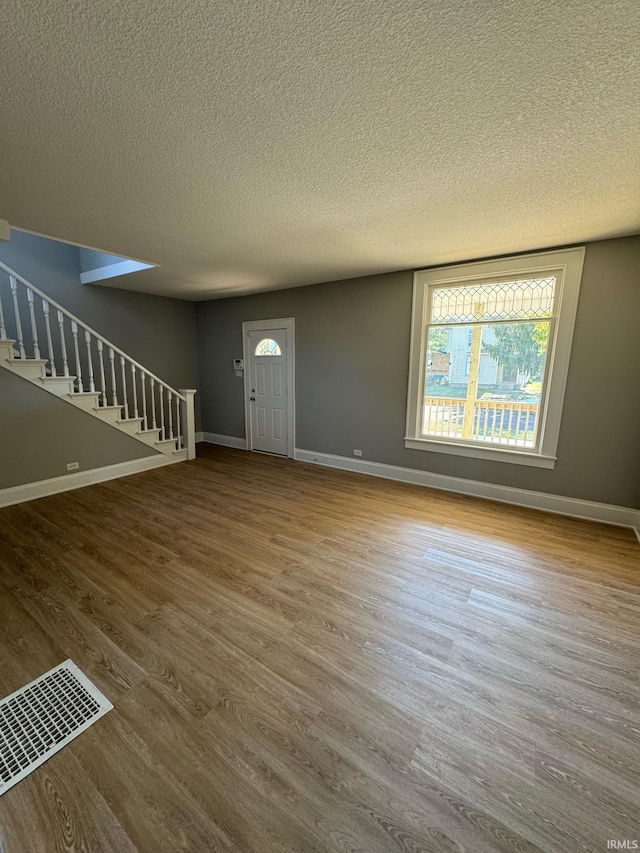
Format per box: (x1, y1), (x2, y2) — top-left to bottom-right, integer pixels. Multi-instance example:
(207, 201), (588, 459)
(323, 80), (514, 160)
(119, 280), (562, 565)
(294, 449), (640, 541)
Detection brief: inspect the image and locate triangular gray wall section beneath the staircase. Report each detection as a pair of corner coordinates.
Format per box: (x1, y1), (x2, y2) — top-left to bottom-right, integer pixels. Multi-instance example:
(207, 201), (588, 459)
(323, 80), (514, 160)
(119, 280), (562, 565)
(0, 368), (157, 489)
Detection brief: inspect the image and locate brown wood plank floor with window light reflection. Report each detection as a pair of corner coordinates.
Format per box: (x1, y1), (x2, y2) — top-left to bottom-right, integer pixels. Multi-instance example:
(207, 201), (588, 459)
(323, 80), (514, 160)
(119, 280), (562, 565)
(0, 447), (640, 853)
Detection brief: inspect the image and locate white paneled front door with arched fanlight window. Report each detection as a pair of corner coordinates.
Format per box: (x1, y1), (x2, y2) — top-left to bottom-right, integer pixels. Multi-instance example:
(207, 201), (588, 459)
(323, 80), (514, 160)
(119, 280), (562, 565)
(248, 329), (290, 456)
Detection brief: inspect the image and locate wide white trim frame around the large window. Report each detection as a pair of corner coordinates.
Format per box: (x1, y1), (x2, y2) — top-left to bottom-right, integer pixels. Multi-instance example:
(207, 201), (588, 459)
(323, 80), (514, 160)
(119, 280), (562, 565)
(404, 246), (585, 468)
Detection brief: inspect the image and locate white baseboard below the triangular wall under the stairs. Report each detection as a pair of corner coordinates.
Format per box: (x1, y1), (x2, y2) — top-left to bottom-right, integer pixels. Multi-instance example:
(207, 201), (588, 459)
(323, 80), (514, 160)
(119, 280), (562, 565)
(0, 453), (182, 508)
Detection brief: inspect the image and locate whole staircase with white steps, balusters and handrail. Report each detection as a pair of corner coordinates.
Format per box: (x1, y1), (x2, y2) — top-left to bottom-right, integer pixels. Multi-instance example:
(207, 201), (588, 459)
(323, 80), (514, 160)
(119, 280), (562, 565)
(0, 261), (195, 462)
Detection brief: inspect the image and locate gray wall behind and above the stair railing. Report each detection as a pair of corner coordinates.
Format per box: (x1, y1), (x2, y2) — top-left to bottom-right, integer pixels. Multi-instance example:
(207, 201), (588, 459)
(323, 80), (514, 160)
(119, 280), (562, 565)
(0, 229), (200, 423)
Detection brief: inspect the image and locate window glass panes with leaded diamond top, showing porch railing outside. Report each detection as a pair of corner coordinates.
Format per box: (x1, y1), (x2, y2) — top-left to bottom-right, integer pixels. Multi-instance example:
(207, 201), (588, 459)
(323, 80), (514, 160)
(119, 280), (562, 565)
(422, 277), (555, 448)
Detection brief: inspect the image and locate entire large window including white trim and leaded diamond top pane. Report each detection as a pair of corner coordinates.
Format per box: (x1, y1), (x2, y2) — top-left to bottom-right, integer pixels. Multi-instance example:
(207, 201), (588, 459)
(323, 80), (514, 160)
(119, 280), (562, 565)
(405, 249), (584, 467)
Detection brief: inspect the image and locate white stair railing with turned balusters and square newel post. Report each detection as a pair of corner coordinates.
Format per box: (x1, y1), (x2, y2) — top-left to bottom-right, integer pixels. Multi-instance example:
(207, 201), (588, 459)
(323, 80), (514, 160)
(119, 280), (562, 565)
(0, 261), (195, 459)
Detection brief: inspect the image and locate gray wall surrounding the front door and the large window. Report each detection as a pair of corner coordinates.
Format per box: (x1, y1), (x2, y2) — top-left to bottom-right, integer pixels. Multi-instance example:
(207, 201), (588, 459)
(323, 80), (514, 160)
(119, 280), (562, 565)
(197, 237), (640, 507)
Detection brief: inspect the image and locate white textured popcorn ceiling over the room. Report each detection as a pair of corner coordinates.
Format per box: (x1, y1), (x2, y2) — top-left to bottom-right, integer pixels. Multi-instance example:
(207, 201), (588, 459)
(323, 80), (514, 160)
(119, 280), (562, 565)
(0, 0), (640, 299)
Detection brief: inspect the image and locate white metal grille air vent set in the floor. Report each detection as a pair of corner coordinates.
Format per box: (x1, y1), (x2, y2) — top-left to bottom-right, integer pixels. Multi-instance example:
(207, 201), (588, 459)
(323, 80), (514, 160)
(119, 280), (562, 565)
(0, 660), (113, 796)
